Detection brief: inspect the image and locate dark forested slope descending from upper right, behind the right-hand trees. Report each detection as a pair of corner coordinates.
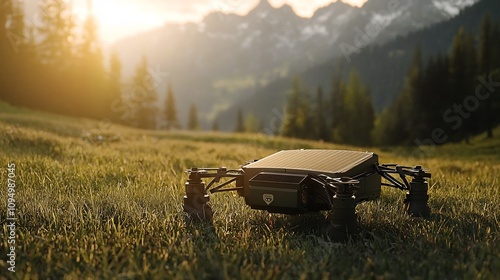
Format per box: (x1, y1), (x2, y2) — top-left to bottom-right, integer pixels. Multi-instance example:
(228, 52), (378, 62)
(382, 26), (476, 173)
(226, 0), (500, 142)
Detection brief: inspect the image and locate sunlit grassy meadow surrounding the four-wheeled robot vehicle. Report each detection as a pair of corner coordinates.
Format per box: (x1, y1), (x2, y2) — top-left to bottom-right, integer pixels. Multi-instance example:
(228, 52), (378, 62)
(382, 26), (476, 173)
(0, 101), (500, 279)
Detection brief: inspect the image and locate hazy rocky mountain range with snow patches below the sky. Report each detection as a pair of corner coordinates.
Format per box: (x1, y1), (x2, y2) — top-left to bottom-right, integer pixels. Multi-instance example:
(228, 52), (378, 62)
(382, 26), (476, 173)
(114, 0), (477, 130)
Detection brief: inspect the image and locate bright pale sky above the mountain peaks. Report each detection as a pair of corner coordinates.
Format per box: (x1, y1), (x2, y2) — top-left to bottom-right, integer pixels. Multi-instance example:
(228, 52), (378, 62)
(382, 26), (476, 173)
(25, 0), (366, 43)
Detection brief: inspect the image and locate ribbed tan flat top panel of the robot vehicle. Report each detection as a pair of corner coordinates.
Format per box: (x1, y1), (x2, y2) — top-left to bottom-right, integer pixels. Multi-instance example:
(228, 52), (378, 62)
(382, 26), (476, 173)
(244, 150), (374, 173)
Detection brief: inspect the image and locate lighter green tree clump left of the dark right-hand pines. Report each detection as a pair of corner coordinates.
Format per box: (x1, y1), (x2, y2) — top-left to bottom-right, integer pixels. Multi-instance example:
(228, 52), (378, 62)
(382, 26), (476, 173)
(281, 71), (375, 145)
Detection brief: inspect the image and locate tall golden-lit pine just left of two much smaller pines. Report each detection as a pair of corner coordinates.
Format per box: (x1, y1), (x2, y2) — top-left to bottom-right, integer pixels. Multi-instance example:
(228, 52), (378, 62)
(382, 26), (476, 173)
(131, 56), (158, 129)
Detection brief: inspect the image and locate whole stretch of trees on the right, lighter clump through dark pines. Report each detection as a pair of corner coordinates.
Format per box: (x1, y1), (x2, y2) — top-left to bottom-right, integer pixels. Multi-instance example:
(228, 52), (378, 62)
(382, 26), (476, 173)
(281, 15), (500, 145)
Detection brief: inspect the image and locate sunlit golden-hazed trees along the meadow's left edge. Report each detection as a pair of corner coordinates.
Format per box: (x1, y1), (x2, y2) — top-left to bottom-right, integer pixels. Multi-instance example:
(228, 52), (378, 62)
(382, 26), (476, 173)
(0, 0), (203, 129)
